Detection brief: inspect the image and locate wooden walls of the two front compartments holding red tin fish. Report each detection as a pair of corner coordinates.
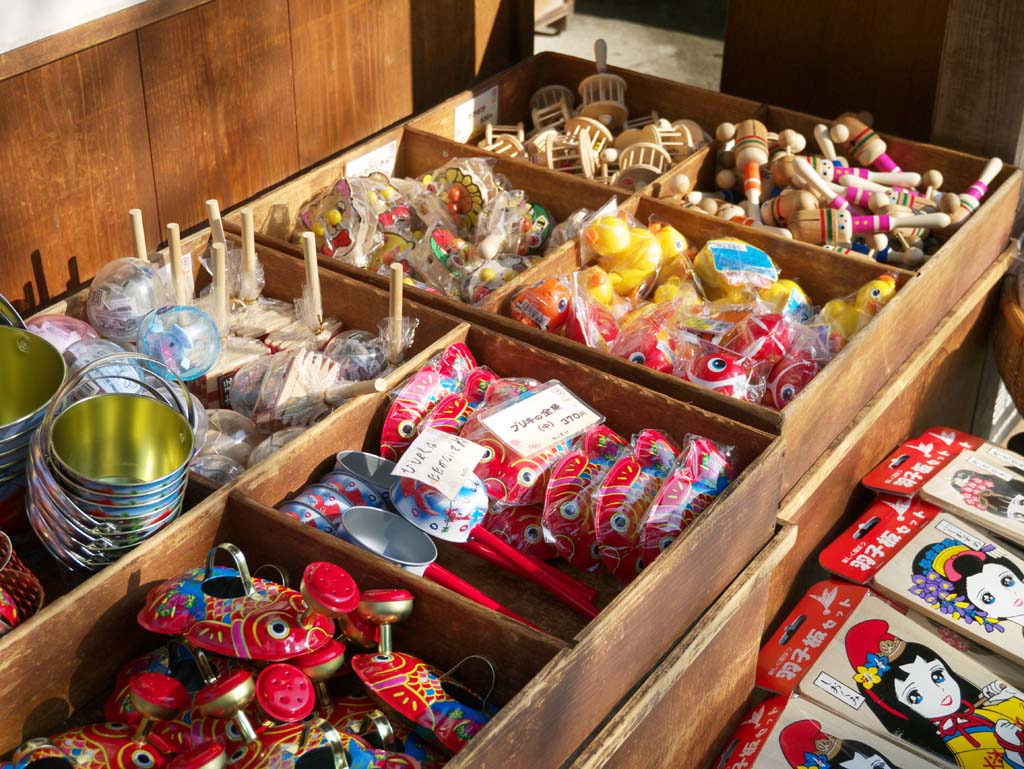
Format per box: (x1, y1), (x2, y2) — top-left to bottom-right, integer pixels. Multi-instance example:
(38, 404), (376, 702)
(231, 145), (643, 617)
(0, 324), (782, 767)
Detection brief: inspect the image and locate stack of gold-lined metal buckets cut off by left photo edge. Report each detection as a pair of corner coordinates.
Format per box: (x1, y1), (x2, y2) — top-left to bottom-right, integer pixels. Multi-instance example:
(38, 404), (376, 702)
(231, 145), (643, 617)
(0, 326), (65, 500)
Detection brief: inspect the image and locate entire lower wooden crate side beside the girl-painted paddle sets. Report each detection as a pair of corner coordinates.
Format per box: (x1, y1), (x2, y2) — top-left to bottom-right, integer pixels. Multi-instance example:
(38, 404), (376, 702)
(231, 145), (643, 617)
(544, 244), (1013, 769)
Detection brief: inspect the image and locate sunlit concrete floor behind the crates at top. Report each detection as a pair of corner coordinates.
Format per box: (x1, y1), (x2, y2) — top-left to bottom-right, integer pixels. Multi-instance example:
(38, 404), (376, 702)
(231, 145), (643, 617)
(534, 0), (727, 90)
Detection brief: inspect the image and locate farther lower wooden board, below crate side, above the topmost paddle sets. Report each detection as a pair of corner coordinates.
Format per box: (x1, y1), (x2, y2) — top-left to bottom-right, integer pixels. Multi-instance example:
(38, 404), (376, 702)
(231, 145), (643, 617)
(767, 246), (1012, 624)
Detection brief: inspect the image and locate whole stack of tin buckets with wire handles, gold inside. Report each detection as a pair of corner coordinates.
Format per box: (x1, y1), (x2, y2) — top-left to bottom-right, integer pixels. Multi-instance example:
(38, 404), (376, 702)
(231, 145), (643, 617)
(27, 353), (197, 570)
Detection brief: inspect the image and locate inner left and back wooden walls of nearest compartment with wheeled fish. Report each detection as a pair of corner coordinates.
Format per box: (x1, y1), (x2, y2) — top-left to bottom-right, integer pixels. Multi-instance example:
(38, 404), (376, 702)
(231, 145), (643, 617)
(0, 489), (566, 754)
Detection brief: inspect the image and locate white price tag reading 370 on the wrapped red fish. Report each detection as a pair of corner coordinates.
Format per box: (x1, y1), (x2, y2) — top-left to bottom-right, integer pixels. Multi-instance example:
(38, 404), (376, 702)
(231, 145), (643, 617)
(480, 383), (604, 457)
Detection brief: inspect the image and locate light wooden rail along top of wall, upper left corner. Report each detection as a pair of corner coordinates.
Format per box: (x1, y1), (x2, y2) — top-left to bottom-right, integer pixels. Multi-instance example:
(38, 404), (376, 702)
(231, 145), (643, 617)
(0, 0), (211, 80)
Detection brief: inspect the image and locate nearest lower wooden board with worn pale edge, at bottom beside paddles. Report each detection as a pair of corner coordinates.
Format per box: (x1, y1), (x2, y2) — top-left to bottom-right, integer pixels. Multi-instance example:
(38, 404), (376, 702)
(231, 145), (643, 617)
(569, 526), (797, 769)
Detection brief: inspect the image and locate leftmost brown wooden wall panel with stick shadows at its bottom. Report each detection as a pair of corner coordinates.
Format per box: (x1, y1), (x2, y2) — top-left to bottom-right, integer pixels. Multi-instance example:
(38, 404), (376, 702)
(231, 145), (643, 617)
(0, 34), (160, 311)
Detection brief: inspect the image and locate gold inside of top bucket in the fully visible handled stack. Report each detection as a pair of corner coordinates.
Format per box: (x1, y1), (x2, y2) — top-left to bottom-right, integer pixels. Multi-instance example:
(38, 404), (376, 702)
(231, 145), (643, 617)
(50, 393), (194, 492)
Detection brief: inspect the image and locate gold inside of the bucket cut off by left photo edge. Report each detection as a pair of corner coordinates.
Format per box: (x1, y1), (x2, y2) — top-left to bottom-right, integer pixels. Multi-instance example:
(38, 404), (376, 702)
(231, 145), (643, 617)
(0, 326), (65, 440)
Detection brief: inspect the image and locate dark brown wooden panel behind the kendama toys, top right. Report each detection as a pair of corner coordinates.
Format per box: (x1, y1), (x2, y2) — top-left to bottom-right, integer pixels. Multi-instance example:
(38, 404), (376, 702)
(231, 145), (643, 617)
(722, 0), (950, 139)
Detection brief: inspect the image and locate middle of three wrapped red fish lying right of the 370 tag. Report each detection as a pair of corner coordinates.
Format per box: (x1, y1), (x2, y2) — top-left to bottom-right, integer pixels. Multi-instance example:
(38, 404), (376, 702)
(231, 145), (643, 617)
(594, 429), (679, 583)
